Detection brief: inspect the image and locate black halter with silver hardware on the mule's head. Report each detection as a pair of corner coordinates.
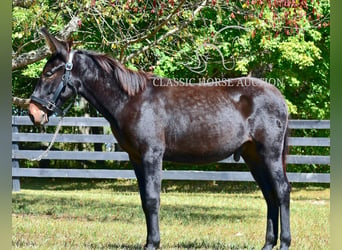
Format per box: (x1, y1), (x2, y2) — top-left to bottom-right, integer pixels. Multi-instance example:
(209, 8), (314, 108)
(31, 50), (77, 116)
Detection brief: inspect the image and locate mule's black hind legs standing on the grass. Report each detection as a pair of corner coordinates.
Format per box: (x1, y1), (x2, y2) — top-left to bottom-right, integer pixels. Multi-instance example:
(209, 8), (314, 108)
(242, 141), (291, 249)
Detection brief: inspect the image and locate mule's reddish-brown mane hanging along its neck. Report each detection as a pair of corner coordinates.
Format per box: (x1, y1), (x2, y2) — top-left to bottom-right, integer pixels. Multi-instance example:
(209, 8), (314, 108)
(85, 51), (149, 96)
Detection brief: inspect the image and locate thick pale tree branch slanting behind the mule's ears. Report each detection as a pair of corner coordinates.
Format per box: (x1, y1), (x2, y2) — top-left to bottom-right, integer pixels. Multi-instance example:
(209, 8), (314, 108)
(12, 16), (80, 70)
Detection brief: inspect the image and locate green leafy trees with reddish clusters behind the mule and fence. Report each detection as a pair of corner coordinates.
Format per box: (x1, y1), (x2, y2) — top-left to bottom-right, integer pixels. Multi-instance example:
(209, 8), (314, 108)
(12, 0), (330, 172)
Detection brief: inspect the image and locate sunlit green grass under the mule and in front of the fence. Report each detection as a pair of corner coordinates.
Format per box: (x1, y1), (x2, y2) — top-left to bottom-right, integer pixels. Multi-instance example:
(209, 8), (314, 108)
(12, 179), (330, 249)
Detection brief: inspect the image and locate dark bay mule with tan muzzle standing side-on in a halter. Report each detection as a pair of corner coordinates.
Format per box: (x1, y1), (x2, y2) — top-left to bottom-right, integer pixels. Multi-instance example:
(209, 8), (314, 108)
(29, 29), (291, 249)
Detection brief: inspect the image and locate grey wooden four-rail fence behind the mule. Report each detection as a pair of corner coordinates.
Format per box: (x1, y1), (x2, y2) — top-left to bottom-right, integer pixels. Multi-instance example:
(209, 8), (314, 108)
(12, 116), (330, 191)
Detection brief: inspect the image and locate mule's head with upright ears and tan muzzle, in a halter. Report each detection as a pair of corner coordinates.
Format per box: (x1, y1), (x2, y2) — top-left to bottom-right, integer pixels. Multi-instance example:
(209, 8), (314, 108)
(29, 28), (76, 125)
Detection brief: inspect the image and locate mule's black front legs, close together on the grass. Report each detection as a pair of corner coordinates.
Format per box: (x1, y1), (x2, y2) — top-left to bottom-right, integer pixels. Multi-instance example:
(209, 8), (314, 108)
(134, 151), (162, 249)
